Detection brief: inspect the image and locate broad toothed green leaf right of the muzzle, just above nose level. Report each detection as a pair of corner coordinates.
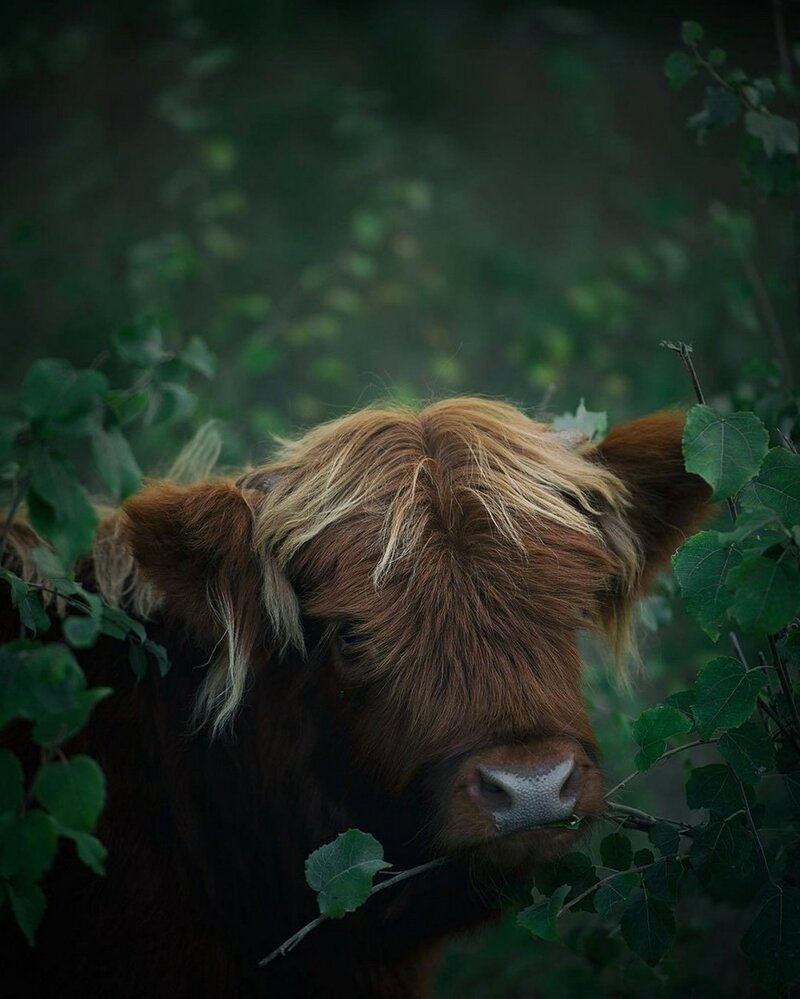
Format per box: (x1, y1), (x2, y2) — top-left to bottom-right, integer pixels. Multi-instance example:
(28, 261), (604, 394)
(694, 656), (766, 739)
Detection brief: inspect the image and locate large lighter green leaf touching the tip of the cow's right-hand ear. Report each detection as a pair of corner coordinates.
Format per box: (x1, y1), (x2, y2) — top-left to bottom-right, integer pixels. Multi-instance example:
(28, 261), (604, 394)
(683, 406), (769, 501)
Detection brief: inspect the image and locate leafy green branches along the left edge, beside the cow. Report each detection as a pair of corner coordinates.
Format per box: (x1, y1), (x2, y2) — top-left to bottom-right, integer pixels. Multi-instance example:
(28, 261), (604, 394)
(0, 322), (213, 944)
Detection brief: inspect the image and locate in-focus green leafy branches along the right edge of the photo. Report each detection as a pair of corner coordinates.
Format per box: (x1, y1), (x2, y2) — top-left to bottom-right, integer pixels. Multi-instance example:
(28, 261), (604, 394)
(284, 13), (800, 988)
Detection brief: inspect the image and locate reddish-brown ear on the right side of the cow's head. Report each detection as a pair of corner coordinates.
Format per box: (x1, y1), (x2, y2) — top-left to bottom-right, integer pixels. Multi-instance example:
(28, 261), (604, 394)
(586, 410), (713, 588)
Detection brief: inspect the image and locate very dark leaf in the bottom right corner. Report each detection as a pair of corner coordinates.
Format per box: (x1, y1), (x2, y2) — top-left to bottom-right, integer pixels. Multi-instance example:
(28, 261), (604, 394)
(741, 888), (800, 985)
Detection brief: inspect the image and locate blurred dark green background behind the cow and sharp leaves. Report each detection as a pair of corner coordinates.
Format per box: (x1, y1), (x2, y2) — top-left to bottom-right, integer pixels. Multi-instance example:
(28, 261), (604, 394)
(0, 0), (793, 999)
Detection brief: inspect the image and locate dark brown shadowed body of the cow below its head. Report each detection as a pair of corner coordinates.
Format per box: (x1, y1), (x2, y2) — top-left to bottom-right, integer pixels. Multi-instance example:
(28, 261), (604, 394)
(0, 612), (516, 999)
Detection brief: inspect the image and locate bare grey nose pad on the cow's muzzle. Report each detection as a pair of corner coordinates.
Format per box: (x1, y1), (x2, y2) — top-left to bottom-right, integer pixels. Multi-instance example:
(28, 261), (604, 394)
(476, 756), (579, 835)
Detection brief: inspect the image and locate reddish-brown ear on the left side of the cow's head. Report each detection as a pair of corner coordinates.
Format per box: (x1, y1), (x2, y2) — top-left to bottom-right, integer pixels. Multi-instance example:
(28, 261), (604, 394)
(123, 482), (303, 688)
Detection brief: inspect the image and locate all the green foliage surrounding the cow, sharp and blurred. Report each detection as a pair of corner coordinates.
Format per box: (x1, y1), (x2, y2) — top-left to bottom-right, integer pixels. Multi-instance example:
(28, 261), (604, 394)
(0, 0), (800, 999)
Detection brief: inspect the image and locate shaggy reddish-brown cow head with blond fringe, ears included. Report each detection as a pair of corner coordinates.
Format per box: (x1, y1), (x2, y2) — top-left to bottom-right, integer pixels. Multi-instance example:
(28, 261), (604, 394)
(126, 399), (707, 871)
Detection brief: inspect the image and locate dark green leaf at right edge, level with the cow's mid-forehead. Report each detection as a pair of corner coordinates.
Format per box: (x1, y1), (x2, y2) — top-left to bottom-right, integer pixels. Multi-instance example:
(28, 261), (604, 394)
(729, 550), (800, 635)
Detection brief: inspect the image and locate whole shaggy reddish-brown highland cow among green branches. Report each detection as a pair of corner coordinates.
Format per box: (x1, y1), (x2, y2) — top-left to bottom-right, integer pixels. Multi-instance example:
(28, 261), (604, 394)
(3, 399), (708, 999)
